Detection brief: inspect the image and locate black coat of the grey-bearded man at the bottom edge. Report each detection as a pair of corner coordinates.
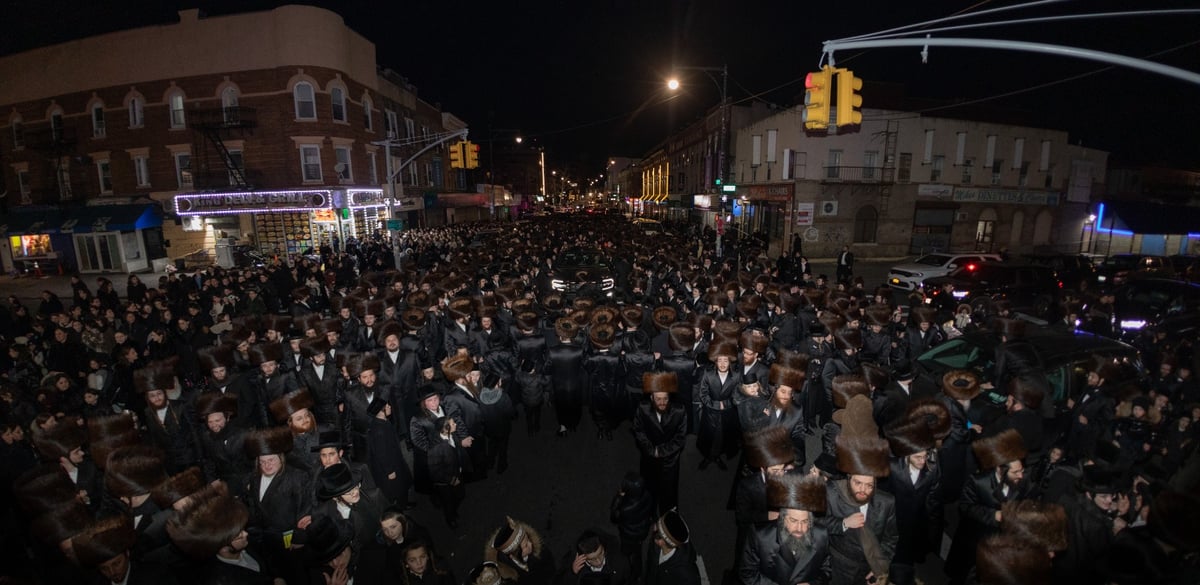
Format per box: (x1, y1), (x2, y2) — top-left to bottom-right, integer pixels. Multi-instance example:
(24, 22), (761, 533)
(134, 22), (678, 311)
(738, 523), (833, 585)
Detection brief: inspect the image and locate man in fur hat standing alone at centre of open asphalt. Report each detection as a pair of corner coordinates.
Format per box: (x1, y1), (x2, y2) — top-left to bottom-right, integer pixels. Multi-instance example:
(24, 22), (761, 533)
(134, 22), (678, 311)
(632, 372), (688, 514)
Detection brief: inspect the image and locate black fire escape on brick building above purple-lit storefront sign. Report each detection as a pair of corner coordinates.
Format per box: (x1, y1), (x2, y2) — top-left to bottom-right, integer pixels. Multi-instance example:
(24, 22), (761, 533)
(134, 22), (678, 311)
(187, 105), (258, 191)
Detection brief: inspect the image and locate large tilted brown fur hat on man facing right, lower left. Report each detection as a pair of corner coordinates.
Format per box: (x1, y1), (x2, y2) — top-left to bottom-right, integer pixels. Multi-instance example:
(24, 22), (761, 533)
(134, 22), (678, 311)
(167, 482), (250, 561)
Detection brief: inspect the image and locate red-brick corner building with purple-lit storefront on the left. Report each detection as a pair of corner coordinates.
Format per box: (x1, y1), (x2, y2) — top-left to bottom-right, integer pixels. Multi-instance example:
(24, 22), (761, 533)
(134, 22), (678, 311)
(0, 6), (468, 271)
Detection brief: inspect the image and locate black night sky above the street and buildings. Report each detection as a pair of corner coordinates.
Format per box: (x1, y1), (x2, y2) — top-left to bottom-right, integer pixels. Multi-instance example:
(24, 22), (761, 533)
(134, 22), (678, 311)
(7, 0), (1200, 174)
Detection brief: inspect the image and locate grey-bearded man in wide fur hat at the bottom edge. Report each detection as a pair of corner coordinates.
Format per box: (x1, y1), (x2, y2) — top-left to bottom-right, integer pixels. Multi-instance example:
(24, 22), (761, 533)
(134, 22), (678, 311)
(738, 475), (830, 585)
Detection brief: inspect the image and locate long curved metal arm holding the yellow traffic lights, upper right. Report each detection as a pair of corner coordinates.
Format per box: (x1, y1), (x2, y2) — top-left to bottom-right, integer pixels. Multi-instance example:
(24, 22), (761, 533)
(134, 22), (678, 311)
(824, 38), (1200, 85)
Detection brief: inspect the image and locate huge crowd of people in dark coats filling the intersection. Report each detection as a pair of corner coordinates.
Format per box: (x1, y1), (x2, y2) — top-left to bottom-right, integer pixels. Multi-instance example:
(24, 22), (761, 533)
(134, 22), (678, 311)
(0, 217), (1200, 585)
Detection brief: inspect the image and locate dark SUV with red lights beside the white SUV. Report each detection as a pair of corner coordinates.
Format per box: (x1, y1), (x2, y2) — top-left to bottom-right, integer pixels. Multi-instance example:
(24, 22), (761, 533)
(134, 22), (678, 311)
(924, 263), (1063, 319)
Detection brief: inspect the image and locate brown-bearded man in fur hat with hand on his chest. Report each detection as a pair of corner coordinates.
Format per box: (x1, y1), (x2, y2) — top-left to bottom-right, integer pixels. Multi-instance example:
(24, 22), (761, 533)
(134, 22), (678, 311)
(827, 431), (900, 585)
